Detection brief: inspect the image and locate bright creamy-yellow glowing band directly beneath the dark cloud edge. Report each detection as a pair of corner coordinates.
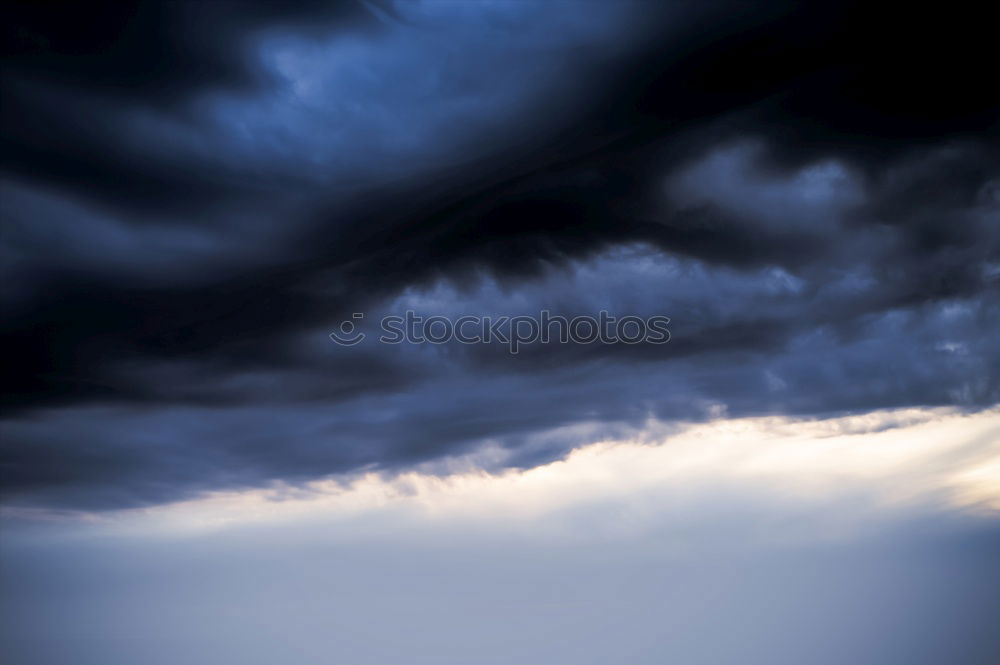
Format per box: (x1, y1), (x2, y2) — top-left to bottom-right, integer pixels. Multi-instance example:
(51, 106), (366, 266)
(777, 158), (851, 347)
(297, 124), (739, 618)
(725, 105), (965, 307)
(58, 408), (1000, 530)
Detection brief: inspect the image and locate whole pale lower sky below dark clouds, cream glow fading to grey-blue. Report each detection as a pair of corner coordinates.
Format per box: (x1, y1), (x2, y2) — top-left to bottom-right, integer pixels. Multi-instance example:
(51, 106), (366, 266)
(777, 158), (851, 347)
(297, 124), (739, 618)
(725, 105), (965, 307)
(2, 409), (1000, 665)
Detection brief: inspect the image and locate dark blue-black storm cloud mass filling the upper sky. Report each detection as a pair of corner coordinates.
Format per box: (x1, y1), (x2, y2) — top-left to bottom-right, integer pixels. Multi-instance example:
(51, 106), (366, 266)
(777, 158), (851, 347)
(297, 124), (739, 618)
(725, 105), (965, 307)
(2, 2), (1000, 507)
